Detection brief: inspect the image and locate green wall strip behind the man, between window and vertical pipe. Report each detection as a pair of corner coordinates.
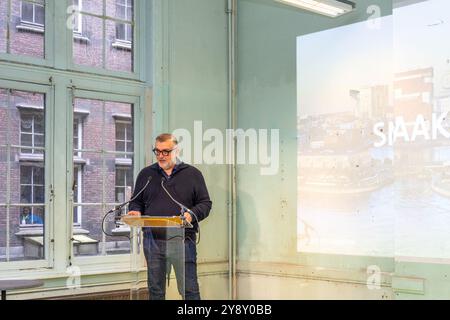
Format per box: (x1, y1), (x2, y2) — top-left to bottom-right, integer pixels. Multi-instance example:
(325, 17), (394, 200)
(154, 0), (229, 299)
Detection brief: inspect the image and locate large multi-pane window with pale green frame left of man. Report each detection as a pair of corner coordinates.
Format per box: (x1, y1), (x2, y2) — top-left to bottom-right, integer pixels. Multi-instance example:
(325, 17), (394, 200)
(0, 0), (146, 277)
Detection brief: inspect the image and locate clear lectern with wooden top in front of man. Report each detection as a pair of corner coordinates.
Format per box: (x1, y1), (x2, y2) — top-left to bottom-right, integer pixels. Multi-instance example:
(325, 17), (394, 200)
(121, 215), (192, 300)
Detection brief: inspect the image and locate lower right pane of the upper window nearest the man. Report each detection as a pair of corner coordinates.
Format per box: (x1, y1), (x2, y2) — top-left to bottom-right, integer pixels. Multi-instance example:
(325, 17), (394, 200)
(106, 20), (133, 72)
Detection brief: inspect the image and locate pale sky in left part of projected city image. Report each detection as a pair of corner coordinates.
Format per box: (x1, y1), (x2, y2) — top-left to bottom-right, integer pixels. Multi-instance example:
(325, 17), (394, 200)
(297, 17), (392, 116)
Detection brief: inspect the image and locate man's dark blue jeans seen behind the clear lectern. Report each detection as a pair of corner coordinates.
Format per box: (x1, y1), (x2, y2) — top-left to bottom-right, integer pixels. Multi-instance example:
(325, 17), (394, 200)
(144, 234), (200, 300)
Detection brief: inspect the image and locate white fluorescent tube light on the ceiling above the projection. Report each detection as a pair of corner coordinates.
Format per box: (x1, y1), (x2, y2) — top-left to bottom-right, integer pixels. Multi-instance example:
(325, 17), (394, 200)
(275, 0), (354, 18)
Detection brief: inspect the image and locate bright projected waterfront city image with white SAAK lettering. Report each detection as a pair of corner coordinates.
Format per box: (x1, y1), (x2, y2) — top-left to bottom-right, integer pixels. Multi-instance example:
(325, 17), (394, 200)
(297, 0), (450, 259)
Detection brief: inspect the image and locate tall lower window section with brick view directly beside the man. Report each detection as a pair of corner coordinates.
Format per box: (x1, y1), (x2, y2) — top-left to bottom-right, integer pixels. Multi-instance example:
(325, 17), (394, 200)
(73, 98), (134, 256)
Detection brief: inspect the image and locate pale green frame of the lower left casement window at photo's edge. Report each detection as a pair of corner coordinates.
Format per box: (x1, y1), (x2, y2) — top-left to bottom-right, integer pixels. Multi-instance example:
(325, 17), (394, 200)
(0, 77), (54, 271)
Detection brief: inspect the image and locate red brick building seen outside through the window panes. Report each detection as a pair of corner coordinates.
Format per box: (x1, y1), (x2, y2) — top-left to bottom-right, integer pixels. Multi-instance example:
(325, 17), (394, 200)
(0, 0), (134, 261)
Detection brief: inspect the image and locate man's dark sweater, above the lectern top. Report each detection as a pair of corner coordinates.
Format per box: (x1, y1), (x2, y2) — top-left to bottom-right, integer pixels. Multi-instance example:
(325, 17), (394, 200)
(129, 163), (212, 233)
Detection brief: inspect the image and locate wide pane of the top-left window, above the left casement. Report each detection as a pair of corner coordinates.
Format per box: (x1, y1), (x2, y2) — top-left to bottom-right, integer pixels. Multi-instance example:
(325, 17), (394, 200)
(9, 0), (45, 58)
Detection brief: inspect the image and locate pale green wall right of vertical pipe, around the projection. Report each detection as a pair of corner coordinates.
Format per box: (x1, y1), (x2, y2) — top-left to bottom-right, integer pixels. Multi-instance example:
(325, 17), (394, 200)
(237, 0), (394, 299)
